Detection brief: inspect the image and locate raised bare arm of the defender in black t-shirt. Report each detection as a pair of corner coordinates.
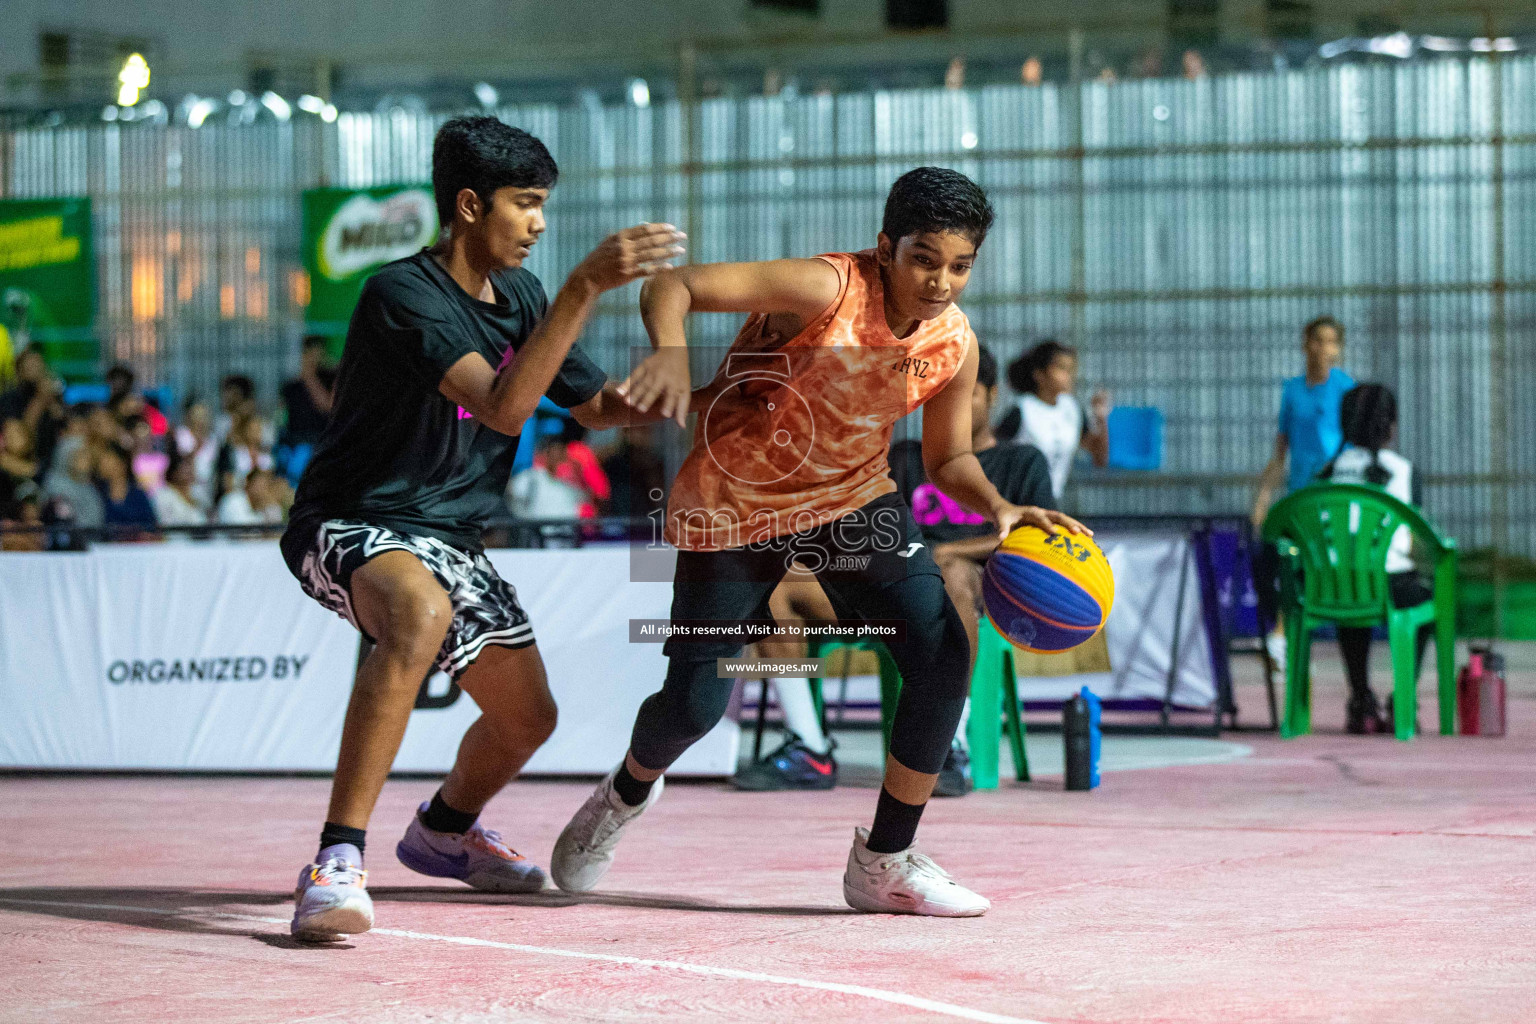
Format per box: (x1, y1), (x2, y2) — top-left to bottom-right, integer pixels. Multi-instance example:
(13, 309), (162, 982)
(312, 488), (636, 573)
(438, 224), (684, 436)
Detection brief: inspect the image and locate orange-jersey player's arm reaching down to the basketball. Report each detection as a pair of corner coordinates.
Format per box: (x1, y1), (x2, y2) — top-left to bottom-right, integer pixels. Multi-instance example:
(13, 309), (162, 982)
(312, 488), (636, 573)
(923, 345), (1094, 537)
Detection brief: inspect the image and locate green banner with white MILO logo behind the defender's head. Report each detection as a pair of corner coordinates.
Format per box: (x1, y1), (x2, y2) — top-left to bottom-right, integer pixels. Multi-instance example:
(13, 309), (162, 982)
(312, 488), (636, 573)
(304, 184), (438, 337)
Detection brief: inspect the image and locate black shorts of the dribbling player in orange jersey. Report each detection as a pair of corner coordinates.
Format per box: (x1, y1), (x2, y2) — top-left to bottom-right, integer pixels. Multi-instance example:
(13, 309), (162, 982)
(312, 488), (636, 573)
(662, 494), (943, 659)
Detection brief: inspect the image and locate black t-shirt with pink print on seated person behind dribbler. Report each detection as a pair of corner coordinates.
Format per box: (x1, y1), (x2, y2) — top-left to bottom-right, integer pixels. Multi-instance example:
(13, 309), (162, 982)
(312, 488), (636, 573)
(891, 439), (1055, 543)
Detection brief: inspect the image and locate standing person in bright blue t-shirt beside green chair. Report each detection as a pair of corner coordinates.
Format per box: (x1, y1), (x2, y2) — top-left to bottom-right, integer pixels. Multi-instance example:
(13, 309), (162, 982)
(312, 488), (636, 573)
(1252, 316), (1355, 668)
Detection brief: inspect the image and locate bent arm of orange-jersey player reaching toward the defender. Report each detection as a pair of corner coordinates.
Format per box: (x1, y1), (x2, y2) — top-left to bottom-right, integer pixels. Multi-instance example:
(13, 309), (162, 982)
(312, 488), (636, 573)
(619, 259), (842, 425)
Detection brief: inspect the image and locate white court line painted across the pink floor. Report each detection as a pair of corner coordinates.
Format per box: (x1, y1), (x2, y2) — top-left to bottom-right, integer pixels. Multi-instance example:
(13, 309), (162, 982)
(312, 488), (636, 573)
(0, 897), (1044, 1024)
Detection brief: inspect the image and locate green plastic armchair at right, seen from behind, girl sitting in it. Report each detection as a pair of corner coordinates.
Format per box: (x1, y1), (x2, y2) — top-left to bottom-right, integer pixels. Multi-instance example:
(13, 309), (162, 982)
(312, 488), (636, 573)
(1264, 482), (1456, 740)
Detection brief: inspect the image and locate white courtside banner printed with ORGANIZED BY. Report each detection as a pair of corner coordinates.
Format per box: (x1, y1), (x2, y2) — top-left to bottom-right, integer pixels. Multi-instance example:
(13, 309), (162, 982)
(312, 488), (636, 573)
(0, 542), (737, 775)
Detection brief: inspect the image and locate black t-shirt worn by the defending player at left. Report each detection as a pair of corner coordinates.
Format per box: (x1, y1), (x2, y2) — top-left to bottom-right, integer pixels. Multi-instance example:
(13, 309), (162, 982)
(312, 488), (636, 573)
(290, 250), (607, 551)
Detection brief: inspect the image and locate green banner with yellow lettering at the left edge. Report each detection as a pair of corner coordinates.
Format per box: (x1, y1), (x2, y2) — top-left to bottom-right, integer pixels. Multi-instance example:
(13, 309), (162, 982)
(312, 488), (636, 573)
(0, 198), (97, 378)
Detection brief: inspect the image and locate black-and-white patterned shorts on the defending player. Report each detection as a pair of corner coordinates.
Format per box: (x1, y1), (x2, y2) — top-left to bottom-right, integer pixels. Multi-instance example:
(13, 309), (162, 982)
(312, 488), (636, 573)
(295, 519), (535, 680)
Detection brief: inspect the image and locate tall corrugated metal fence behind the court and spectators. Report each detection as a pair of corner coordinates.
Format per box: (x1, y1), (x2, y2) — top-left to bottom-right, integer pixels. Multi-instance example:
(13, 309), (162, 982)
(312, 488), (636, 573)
(0, 57), (1536, 554)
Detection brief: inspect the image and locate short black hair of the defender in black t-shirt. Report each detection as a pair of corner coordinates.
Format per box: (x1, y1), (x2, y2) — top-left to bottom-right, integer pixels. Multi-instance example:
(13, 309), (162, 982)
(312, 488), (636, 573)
(432, 117), (561, 227)
